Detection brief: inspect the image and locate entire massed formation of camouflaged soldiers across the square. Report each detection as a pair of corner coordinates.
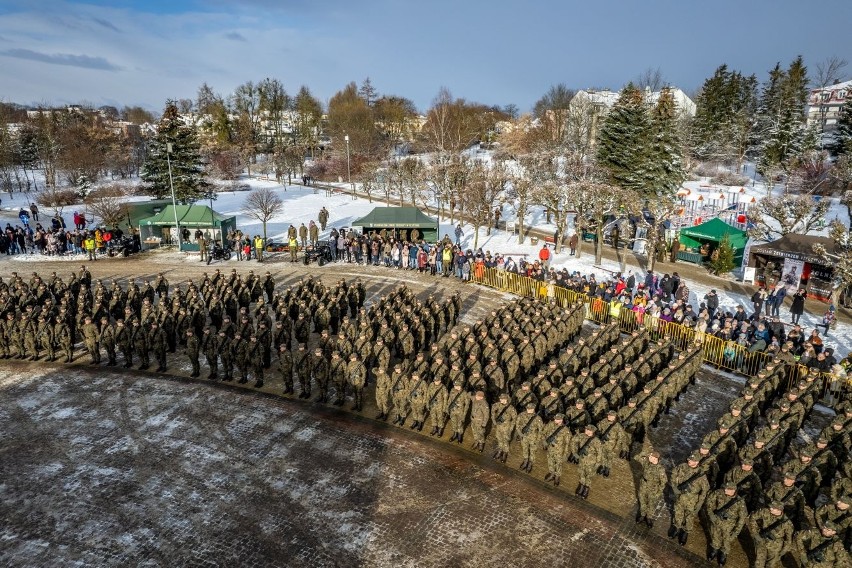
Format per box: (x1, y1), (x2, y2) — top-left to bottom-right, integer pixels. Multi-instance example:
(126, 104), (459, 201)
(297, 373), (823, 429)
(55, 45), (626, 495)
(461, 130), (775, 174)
(0, 266), (852, 566)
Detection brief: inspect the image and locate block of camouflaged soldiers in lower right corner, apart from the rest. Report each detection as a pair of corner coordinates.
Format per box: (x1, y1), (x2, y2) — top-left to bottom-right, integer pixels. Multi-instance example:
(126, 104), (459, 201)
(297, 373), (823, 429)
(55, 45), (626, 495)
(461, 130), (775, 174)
(668, 344), (852, 567)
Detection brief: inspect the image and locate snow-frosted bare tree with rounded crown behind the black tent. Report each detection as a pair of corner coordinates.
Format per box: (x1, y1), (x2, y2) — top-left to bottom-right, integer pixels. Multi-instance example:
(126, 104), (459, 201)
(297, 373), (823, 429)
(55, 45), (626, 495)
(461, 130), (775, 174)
(748, 192), (830, 241)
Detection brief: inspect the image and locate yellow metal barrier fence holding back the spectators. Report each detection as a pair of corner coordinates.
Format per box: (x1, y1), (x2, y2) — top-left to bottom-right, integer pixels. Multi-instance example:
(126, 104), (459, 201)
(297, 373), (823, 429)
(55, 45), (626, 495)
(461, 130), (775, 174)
(471, 266), (844, 403)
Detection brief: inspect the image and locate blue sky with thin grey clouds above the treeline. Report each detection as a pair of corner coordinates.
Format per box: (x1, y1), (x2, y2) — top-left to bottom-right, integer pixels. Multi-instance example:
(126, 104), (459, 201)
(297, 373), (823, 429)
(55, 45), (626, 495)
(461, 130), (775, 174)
(0, 0), (852, 112)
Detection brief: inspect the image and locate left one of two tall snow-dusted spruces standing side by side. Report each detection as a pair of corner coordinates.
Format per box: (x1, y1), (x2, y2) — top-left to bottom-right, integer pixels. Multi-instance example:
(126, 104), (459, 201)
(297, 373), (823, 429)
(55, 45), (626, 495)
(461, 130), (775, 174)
(597, 83), (654, 196)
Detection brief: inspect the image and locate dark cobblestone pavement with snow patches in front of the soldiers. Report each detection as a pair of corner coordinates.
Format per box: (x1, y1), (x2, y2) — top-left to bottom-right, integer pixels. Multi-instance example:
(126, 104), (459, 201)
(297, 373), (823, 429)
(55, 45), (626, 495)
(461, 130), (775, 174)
(0, 364), (712, 567)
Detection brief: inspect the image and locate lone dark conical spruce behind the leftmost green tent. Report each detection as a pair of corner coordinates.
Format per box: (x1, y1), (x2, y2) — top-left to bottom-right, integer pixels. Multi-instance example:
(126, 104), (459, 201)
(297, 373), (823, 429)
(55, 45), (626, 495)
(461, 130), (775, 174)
(141, 100), (210, 203)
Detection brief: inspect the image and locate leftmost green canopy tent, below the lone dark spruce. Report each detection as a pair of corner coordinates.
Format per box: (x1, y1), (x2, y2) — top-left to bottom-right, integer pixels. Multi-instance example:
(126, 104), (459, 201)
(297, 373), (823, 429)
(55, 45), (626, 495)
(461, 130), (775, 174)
(139, 205), (237, 251)
